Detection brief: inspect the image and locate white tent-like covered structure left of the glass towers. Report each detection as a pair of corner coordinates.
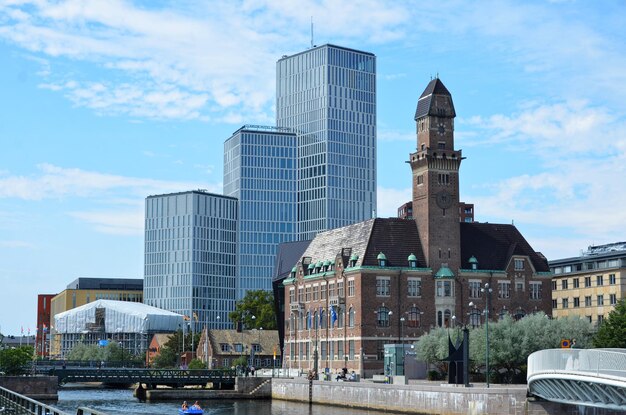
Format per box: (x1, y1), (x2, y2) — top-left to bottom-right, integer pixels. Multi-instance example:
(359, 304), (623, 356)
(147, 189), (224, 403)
(53, 300), (184, 357)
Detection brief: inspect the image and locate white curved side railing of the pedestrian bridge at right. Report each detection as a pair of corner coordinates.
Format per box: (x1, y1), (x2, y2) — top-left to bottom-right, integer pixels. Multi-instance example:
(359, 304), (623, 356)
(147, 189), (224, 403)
(527, 349), (626, 380)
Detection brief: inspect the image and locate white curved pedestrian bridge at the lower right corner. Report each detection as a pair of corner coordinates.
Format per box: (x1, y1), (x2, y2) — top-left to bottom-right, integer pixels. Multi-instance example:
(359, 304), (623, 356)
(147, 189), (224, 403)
(526, 349), (626, 411)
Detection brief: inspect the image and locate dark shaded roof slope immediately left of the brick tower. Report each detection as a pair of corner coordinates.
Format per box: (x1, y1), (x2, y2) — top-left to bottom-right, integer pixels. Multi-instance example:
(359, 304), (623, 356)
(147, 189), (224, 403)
(361, 218), (426, 268)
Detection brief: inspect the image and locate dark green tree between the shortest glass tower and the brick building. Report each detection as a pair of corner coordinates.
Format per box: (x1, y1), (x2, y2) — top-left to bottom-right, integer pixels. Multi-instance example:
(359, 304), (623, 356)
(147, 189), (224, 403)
(228, 290), (276, 330)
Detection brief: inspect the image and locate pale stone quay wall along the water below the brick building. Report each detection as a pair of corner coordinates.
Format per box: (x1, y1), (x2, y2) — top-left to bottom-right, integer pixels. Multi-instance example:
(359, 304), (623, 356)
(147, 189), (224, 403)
(272, 379), (623, 415)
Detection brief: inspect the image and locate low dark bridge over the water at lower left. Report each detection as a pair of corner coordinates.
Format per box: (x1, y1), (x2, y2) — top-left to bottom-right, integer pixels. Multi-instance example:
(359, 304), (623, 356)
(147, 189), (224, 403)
(48, 367), (235, 389)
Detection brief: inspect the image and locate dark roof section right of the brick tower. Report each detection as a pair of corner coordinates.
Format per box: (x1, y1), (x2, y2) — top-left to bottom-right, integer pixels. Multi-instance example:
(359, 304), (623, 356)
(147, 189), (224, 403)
(461, 222), (550, 272)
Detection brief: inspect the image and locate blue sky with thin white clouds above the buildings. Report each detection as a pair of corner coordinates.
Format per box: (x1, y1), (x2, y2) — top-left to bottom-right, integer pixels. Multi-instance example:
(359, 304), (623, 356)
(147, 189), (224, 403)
(0, 0), (626, 335)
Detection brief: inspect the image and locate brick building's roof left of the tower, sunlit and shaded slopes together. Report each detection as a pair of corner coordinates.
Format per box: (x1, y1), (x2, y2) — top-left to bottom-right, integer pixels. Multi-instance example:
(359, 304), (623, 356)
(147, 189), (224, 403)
(304, 218), (426, 267)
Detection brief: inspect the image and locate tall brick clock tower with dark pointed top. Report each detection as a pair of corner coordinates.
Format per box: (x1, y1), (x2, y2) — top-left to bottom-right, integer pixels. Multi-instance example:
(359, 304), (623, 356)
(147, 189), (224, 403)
(410, 78), (462, 278)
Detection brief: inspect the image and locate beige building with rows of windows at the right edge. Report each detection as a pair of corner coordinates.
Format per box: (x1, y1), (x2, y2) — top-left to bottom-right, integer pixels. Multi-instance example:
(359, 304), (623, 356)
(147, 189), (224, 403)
(549, 242), (626, 324)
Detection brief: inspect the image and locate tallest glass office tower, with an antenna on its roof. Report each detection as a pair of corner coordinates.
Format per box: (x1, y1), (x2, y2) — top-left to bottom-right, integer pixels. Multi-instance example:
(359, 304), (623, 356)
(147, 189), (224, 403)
(276, 45), (376, 240)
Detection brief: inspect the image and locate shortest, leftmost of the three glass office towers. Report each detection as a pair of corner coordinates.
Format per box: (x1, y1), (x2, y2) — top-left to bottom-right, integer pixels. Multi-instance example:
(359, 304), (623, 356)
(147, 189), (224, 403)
(143, 190), (237, 331)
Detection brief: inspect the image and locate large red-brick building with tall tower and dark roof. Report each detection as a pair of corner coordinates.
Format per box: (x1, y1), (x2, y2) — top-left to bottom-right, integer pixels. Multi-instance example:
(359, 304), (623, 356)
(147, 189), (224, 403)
(283, 79), (552, 376)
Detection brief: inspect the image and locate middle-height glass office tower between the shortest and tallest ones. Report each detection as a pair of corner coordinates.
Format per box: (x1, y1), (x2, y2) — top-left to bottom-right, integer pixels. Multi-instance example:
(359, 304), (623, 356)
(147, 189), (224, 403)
(224, 125), (297, 299)
